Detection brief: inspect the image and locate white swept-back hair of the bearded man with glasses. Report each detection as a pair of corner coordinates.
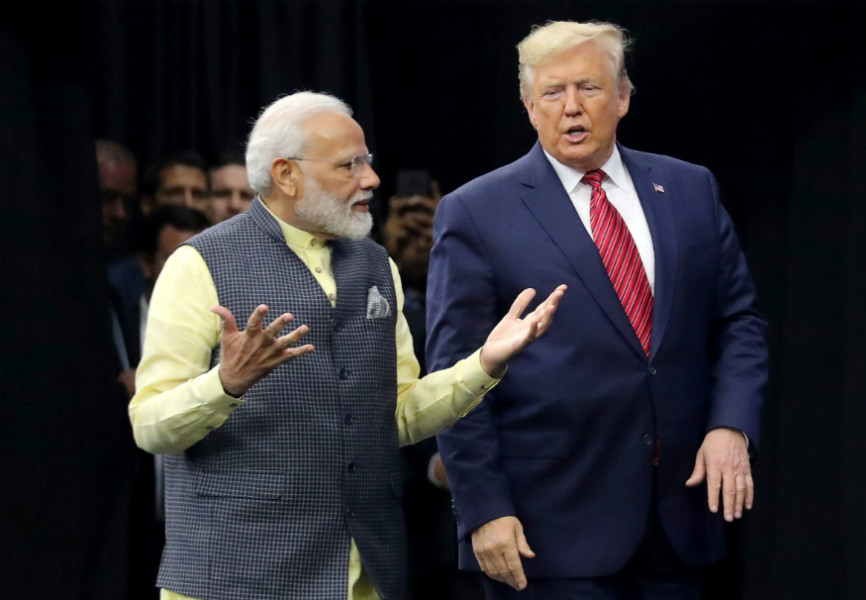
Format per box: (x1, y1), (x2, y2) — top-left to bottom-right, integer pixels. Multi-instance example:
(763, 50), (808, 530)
(246, 92), (352, 194)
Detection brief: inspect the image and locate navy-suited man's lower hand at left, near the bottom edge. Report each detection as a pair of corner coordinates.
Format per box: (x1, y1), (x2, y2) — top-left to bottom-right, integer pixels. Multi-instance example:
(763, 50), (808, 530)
(472, 517), (535, 591)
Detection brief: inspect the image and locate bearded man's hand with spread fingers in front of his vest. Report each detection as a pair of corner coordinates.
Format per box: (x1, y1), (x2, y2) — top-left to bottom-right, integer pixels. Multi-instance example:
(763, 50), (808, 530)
(211, 304), (315, 398)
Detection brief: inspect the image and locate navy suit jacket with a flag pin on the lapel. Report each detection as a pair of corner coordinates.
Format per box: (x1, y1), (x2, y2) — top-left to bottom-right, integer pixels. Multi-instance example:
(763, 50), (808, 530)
(427, 143), (767, 577)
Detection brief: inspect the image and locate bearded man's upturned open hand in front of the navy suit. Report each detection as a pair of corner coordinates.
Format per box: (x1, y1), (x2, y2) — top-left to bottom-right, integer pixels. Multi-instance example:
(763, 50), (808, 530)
(481, 284), (568, 378)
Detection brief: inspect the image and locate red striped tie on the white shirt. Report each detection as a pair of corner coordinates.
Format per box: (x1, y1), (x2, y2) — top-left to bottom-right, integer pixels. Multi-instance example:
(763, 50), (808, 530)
(581, 169), (653, 358)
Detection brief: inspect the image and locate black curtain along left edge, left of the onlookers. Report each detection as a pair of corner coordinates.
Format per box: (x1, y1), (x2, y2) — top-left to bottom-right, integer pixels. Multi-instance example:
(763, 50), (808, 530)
(0, 3), (135, 600)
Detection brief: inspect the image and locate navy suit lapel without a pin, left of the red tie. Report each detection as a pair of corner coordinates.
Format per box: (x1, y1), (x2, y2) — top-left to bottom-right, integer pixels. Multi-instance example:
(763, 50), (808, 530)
(521, 143), (655, 357)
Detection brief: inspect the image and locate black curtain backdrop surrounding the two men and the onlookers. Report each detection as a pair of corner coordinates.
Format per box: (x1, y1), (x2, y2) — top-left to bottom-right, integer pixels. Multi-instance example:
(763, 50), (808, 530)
(0, 0), (866, 600)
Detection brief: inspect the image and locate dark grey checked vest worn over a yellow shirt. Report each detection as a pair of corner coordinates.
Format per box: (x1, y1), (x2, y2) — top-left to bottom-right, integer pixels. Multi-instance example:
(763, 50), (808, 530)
(158, 200), (406, 600)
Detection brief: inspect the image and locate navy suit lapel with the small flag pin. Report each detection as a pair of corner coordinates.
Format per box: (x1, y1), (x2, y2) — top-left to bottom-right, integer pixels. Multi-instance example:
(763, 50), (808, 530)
(619, 146), (680, 357)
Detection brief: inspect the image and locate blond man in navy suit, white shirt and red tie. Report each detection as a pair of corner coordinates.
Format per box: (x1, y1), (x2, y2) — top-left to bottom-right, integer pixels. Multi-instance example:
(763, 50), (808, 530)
(427, 22), (767, 600)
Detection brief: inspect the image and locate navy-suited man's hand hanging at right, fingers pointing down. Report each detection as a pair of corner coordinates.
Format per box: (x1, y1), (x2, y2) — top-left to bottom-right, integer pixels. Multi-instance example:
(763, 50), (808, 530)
(686, 427), (755, 523)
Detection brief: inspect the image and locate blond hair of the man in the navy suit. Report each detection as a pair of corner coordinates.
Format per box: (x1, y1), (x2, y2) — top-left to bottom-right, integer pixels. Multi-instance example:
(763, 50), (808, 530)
(517, 21), (634, 100)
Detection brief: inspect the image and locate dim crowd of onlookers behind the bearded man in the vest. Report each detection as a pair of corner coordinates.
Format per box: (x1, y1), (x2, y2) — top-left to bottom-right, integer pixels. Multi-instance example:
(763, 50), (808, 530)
(96, 140), (483, 600)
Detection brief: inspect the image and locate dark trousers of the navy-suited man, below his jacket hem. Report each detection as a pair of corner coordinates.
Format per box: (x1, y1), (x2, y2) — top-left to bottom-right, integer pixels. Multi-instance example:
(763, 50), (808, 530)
(484, 509), (704, 600)
